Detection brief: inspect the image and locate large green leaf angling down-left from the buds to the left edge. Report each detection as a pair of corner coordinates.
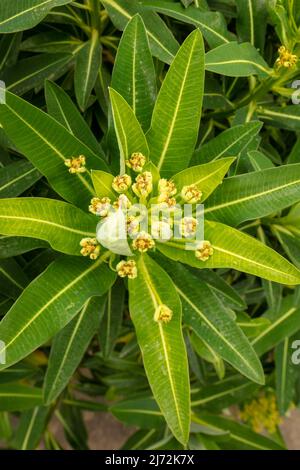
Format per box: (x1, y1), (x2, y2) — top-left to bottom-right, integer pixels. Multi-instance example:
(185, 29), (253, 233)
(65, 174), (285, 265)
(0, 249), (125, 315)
(0, 257), (115, 369)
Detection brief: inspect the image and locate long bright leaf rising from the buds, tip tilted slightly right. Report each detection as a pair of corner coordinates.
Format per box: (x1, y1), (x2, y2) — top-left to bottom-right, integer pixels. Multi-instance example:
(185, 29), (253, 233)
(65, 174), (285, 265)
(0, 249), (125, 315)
(147, 30), (204, 177)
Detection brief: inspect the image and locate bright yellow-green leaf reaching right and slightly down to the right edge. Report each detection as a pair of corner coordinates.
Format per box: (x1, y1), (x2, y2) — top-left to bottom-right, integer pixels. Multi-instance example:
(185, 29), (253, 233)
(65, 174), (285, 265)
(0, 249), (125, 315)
(157, 221), (300, 285)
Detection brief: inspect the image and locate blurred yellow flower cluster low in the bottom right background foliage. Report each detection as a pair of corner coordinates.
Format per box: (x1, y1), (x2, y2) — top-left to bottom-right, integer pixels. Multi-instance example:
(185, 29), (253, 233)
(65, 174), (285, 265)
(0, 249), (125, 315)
(240, 393), (281, 434)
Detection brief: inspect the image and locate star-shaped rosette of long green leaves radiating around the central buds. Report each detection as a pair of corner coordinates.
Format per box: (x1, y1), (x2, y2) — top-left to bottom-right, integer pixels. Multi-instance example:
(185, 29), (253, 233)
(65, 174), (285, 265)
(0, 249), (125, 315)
(0, 16), (300, 447)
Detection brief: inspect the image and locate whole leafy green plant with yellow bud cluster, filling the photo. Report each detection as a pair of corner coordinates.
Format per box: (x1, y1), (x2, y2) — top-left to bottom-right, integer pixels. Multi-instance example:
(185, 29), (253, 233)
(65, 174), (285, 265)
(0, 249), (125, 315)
(0, 0), (300, 449)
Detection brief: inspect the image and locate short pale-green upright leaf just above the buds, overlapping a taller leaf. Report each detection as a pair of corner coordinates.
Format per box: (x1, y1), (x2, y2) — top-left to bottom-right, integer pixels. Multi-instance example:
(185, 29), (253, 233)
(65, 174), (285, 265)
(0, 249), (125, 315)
(109, 88), (149, 174)
